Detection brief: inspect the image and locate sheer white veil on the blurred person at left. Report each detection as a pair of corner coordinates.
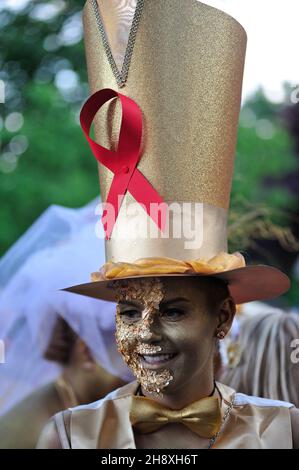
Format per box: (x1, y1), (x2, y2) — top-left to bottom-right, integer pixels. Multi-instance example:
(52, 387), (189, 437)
(0, 197), (132, 415)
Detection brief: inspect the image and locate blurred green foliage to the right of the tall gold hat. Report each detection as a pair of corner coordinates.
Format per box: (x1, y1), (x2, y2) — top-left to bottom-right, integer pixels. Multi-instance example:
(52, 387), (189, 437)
(229, 89), (298, 251)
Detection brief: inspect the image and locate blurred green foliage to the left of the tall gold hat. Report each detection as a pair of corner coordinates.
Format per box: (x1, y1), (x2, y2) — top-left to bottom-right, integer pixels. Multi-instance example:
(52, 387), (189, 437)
(0, 0), (99, 254)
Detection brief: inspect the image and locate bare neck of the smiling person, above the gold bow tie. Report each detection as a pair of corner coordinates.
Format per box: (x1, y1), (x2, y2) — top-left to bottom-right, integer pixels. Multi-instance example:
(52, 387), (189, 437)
(141, 369), (218, 410)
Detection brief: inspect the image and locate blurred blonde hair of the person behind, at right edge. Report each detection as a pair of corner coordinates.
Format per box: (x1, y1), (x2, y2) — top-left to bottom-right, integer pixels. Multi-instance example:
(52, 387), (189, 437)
(220, 307), (299, 407)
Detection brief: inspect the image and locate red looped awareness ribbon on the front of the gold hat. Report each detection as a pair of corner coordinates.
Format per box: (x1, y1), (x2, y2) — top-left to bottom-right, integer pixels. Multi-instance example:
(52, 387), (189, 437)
(80, 88), (165, 240)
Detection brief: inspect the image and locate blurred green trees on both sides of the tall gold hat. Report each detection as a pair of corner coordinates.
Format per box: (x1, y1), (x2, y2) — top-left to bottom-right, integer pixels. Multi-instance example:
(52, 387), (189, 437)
(0, 0), (299, 304)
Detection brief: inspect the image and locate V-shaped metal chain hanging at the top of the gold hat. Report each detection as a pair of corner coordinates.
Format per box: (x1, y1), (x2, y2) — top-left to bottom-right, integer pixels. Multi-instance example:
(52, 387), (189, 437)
(91, 0), (144, 88)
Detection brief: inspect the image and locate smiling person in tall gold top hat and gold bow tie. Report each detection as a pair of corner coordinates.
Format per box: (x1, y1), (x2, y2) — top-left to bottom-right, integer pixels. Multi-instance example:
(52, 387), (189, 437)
(38, 0), (299, 449)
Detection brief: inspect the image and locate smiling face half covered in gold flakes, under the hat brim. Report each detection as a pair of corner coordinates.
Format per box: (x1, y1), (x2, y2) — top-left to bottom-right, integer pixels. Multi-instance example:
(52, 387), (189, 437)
(116, 277), (234, 395)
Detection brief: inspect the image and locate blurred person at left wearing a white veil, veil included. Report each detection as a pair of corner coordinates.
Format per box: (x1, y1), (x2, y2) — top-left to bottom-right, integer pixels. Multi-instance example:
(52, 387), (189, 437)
(0, 199), (132, 449)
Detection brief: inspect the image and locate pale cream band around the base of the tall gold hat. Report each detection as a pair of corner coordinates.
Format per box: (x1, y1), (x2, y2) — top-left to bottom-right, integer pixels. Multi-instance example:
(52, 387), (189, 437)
(106, 201), (227, 263)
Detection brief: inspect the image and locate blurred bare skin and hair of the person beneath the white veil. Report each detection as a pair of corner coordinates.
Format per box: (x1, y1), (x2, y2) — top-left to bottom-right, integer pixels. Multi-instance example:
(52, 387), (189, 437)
(0, 317), (126, 449)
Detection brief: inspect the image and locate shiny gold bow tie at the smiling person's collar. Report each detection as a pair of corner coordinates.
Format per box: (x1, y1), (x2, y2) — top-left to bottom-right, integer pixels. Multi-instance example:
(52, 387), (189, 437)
(130, 396), (221, 438)
